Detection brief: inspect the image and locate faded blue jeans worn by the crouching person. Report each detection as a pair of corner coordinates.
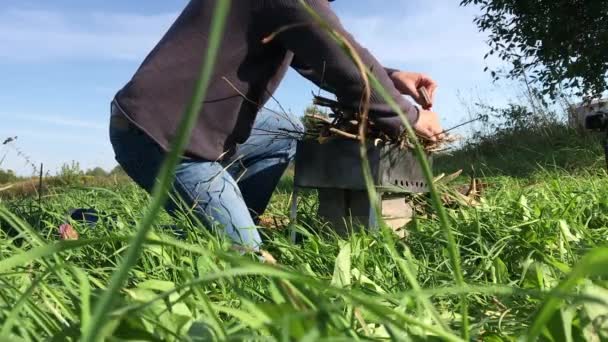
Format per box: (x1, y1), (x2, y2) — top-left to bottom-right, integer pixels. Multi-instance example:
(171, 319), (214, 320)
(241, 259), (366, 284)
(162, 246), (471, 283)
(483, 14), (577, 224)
(110, 105), (303, 250)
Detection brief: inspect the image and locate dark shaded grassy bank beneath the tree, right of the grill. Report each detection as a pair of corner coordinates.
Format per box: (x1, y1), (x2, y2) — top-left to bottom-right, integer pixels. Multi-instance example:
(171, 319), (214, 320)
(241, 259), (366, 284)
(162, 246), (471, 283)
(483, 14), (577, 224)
(435, 122), (606, 178)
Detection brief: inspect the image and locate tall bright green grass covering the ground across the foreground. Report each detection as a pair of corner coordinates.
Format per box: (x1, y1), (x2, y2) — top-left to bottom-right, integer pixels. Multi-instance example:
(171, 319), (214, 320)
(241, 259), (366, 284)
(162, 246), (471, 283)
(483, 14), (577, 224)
(0, 122), (608, 341)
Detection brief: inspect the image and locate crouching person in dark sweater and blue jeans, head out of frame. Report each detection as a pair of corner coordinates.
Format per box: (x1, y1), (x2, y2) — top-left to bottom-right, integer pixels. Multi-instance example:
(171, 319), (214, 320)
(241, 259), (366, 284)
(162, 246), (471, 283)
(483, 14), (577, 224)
(110, 0), (441, 249)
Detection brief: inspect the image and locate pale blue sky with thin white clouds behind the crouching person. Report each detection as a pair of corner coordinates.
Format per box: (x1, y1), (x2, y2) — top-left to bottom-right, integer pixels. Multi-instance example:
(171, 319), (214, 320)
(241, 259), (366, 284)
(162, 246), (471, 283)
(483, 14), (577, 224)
(0, 0), (507, 175)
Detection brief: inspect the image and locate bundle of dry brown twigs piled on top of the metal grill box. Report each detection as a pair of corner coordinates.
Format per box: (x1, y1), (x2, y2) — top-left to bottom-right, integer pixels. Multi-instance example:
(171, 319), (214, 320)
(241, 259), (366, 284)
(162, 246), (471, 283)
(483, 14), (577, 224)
(306, 96), (458, 153)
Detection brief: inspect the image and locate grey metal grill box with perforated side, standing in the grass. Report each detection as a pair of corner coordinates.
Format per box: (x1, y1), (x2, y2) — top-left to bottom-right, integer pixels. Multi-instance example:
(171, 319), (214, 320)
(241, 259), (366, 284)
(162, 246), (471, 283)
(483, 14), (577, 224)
(291, 139), (428, 239)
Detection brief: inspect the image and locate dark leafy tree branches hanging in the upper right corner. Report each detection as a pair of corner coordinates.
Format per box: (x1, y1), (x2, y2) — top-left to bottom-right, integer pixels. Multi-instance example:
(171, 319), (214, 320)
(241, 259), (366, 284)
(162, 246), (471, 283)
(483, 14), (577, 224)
(461, 0), (608, 99)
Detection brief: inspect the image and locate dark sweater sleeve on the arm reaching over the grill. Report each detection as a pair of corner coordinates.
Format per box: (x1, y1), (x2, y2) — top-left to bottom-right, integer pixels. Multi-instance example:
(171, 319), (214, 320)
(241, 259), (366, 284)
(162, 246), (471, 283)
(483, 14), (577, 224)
(265, 0), (418, 136)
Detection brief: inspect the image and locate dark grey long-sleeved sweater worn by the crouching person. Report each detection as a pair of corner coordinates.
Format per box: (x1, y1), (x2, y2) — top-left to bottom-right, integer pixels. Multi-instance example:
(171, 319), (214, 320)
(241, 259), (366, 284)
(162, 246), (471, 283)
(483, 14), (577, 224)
(116, 0), (418, 160)
